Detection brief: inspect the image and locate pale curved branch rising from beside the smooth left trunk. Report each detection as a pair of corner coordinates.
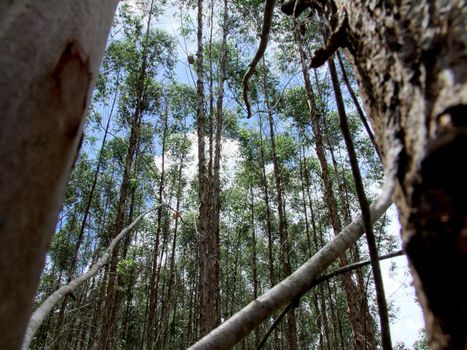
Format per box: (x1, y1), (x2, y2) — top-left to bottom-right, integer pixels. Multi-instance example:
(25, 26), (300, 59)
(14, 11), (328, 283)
(22, 208), (157, 350)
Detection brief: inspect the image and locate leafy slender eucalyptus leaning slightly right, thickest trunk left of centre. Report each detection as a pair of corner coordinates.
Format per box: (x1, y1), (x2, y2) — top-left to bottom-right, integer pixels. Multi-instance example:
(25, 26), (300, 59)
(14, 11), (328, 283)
(99, 1), (173, 349)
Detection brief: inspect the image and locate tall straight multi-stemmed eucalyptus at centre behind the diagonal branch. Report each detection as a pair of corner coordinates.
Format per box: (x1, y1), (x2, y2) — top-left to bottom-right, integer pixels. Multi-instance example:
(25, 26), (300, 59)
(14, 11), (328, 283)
(196, 0), (228, 334)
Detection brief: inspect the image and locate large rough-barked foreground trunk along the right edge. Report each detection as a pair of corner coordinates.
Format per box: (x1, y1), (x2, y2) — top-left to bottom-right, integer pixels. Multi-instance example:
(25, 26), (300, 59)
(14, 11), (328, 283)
(286, 0), (467, 349)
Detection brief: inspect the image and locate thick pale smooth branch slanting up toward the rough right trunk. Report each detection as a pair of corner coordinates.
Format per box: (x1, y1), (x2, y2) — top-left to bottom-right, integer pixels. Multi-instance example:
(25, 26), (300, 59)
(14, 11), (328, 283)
(190, 185), (392, 350)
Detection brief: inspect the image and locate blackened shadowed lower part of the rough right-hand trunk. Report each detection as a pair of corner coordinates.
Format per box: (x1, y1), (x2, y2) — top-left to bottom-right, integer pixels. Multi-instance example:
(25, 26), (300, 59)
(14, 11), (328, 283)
(406, 129), (467, 349)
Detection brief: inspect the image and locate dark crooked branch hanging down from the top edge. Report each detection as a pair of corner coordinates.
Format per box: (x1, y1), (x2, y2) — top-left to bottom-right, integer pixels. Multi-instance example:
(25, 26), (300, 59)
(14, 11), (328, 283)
(243, 0), (276, 118)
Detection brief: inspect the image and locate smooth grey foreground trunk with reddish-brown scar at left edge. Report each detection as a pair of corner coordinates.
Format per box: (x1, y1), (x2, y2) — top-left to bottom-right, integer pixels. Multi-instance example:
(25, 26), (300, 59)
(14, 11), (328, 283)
(0, 0), (117, 349)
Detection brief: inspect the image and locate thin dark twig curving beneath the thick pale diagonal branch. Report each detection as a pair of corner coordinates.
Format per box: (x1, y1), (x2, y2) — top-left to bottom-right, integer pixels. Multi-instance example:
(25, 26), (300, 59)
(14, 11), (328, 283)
(256, 250), (404, 350)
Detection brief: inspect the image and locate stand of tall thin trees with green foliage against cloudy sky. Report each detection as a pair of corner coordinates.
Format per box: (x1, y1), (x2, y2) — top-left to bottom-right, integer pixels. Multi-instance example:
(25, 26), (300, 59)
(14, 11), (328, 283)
(31, 0), (432, 349)
